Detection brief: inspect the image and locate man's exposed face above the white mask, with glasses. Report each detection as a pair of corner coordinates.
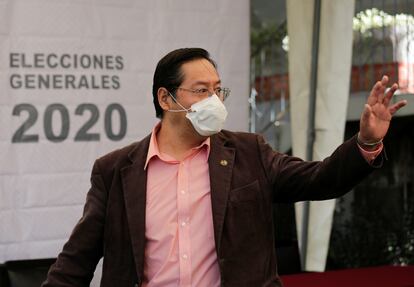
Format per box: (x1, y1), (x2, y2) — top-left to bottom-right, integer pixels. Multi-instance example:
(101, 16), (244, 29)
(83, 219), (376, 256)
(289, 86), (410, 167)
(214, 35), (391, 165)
(172, 59), (221, 108)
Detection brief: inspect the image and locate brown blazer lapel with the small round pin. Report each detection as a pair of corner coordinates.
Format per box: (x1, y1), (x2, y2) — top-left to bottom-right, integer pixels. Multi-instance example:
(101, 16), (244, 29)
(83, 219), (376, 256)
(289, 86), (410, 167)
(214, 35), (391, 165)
(208, 133), (235, 255)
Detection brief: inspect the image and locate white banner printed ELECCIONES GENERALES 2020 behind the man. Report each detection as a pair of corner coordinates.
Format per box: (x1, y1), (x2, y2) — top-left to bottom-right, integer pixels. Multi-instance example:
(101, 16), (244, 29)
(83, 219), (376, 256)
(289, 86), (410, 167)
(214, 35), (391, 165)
(0, 0), (249, 263)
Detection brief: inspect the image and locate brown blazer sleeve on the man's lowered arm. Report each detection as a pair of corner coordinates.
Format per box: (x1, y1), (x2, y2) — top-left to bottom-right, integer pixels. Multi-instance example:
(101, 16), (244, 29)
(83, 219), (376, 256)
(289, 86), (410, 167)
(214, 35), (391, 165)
(42, 161), (107, 287)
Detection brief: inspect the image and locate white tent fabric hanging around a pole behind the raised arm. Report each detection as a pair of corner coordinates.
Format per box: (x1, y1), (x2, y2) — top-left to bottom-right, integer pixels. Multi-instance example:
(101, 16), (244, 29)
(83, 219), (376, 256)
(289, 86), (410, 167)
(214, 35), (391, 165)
(287, 0), (354, 271)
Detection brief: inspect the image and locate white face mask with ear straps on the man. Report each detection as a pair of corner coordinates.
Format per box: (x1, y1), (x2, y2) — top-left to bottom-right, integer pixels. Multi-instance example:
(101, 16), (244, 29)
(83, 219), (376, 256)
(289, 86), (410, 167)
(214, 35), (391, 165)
(168, 93), (227, 136)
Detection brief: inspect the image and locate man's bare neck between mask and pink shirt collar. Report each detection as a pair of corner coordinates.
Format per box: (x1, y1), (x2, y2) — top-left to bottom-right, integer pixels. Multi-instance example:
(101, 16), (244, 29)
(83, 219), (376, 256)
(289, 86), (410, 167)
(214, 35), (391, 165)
(156, 120), (206, 161)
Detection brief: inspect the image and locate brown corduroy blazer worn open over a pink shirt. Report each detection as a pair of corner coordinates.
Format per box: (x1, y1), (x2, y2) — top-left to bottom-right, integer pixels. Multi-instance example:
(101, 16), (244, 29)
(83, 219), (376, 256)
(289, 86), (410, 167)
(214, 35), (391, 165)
(42, 131), (383, 287)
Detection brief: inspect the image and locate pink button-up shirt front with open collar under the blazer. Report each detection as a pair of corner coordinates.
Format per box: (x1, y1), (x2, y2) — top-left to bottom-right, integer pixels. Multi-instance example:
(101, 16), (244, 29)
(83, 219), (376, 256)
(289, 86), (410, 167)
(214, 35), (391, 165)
(143, 124), (220, 287)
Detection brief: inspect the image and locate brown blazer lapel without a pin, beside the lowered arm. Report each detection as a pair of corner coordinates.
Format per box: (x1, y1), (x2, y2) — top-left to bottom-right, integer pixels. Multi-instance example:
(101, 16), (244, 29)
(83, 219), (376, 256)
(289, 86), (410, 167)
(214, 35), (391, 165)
(121, 136), (150, 277)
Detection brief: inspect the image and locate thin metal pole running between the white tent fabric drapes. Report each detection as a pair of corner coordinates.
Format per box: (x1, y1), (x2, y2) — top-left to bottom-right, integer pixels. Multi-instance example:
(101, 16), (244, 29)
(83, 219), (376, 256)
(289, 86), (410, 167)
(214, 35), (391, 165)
(301, 0), (322, 269)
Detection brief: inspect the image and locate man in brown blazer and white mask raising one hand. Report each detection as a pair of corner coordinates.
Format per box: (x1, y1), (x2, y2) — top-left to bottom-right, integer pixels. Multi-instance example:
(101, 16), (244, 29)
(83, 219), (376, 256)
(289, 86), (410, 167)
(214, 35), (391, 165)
(43, 48), (406, 287)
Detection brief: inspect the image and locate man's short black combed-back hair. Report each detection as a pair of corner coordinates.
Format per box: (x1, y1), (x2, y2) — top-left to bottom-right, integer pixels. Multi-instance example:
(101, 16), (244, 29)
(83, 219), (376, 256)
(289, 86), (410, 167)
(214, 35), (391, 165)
(152, 48), (216, 118)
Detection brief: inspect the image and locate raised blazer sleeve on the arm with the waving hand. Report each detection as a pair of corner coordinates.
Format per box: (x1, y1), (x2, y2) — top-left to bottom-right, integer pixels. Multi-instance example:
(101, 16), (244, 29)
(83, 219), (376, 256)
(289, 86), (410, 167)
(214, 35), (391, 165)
(257, 136), (385, 202)
